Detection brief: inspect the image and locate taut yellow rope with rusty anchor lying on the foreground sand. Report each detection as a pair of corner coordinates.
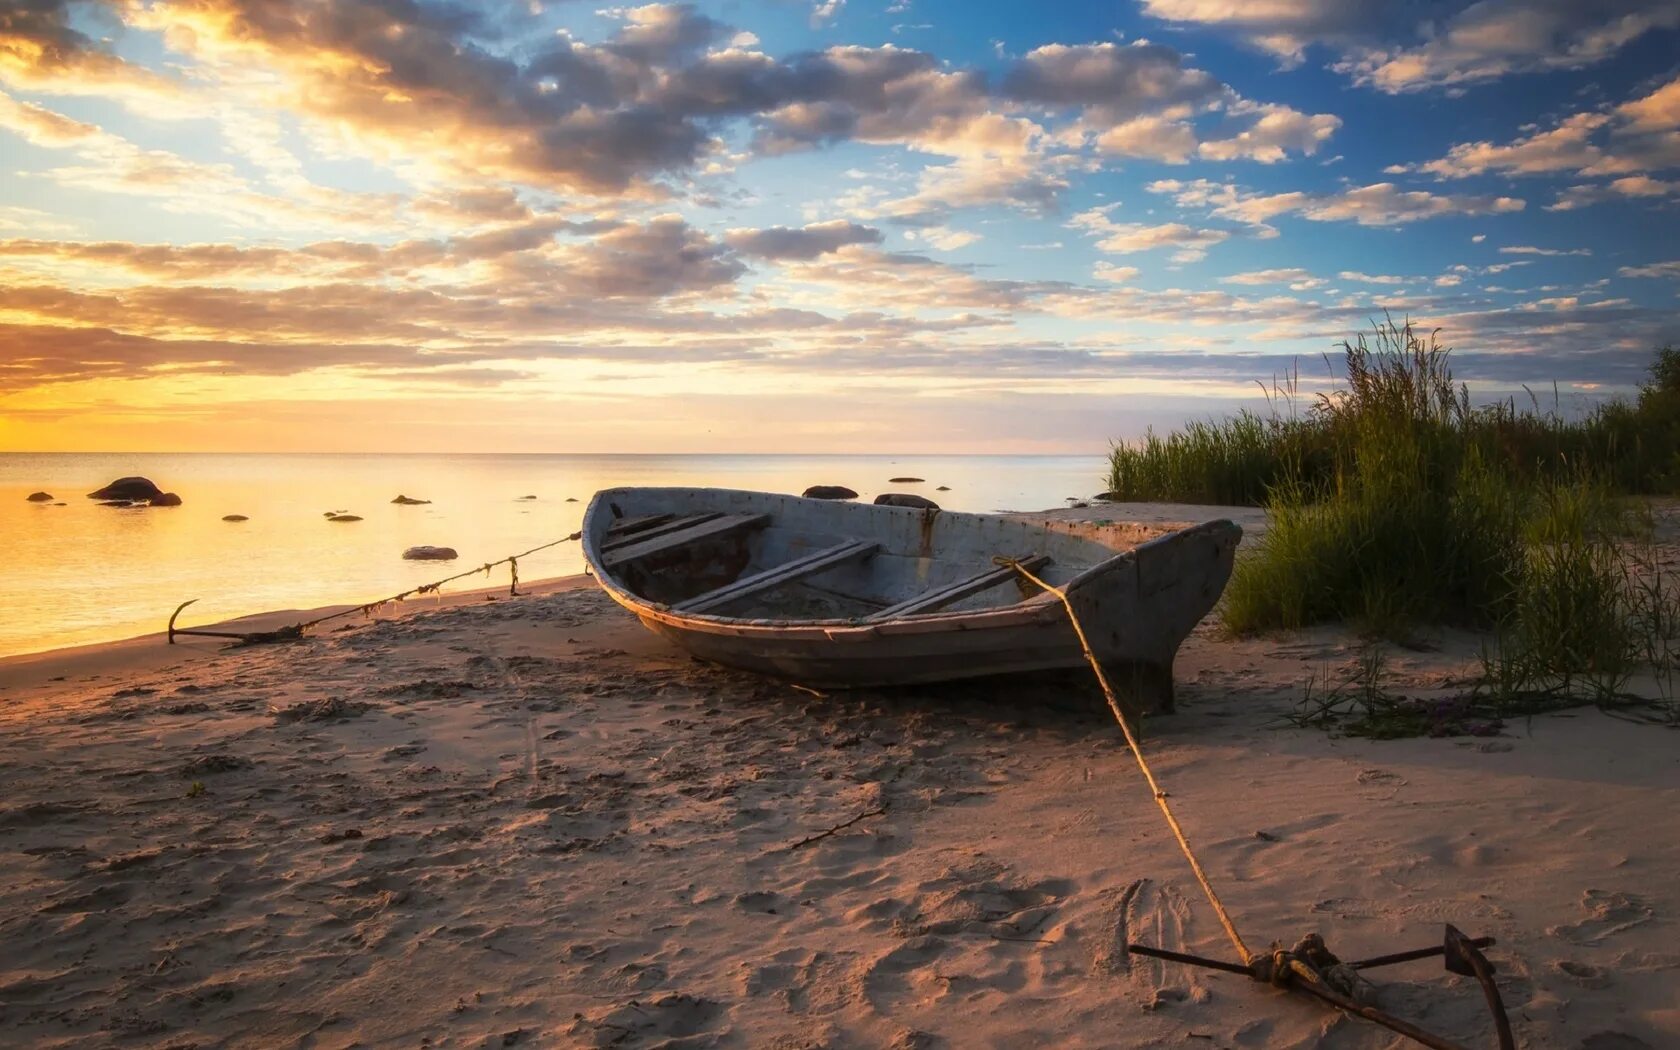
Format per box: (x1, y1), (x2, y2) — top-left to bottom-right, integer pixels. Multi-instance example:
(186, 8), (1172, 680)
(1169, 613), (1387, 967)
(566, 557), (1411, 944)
(991, 554), (1515, 1050)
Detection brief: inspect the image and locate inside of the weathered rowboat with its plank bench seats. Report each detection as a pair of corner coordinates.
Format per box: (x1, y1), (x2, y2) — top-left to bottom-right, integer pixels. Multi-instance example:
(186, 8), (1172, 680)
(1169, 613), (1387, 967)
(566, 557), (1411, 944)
(595, 497), (1142, 623)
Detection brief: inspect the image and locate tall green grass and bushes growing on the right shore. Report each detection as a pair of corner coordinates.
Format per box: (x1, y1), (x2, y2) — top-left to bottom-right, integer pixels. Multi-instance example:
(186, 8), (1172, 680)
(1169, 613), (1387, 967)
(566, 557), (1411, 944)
(1109, 321), (1680, 736)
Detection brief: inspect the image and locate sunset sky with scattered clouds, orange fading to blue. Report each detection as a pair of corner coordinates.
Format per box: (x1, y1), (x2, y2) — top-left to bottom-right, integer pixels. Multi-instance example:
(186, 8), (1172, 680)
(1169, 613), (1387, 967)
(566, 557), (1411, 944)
(0, 0), (1680, 452)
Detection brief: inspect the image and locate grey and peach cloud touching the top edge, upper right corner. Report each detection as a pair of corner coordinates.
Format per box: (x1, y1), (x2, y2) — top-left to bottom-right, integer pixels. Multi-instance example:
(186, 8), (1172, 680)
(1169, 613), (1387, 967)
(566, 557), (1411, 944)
(1144, 0), (1680, 94)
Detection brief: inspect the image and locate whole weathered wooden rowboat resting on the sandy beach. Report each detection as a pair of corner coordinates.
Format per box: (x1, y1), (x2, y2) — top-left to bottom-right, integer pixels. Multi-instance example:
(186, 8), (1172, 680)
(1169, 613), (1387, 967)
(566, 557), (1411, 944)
(583, 489), (1242, 709)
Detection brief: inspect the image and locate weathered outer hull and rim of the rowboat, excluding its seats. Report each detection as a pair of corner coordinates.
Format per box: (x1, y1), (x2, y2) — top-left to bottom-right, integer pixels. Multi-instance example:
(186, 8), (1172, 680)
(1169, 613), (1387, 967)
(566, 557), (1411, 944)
(585, 491), (1242, 709)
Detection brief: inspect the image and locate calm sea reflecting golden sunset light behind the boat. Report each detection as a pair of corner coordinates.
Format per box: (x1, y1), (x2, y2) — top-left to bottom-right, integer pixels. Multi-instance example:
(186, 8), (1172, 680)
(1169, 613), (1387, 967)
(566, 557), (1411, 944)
(0, 454), (1105, 655)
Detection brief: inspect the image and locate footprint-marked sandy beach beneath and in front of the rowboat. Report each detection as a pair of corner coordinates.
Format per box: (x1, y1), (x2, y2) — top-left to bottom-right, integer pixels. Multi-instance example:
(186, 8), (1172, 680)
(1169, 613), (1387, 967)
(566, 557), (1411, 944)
(0, 517), (1680, 1050)
